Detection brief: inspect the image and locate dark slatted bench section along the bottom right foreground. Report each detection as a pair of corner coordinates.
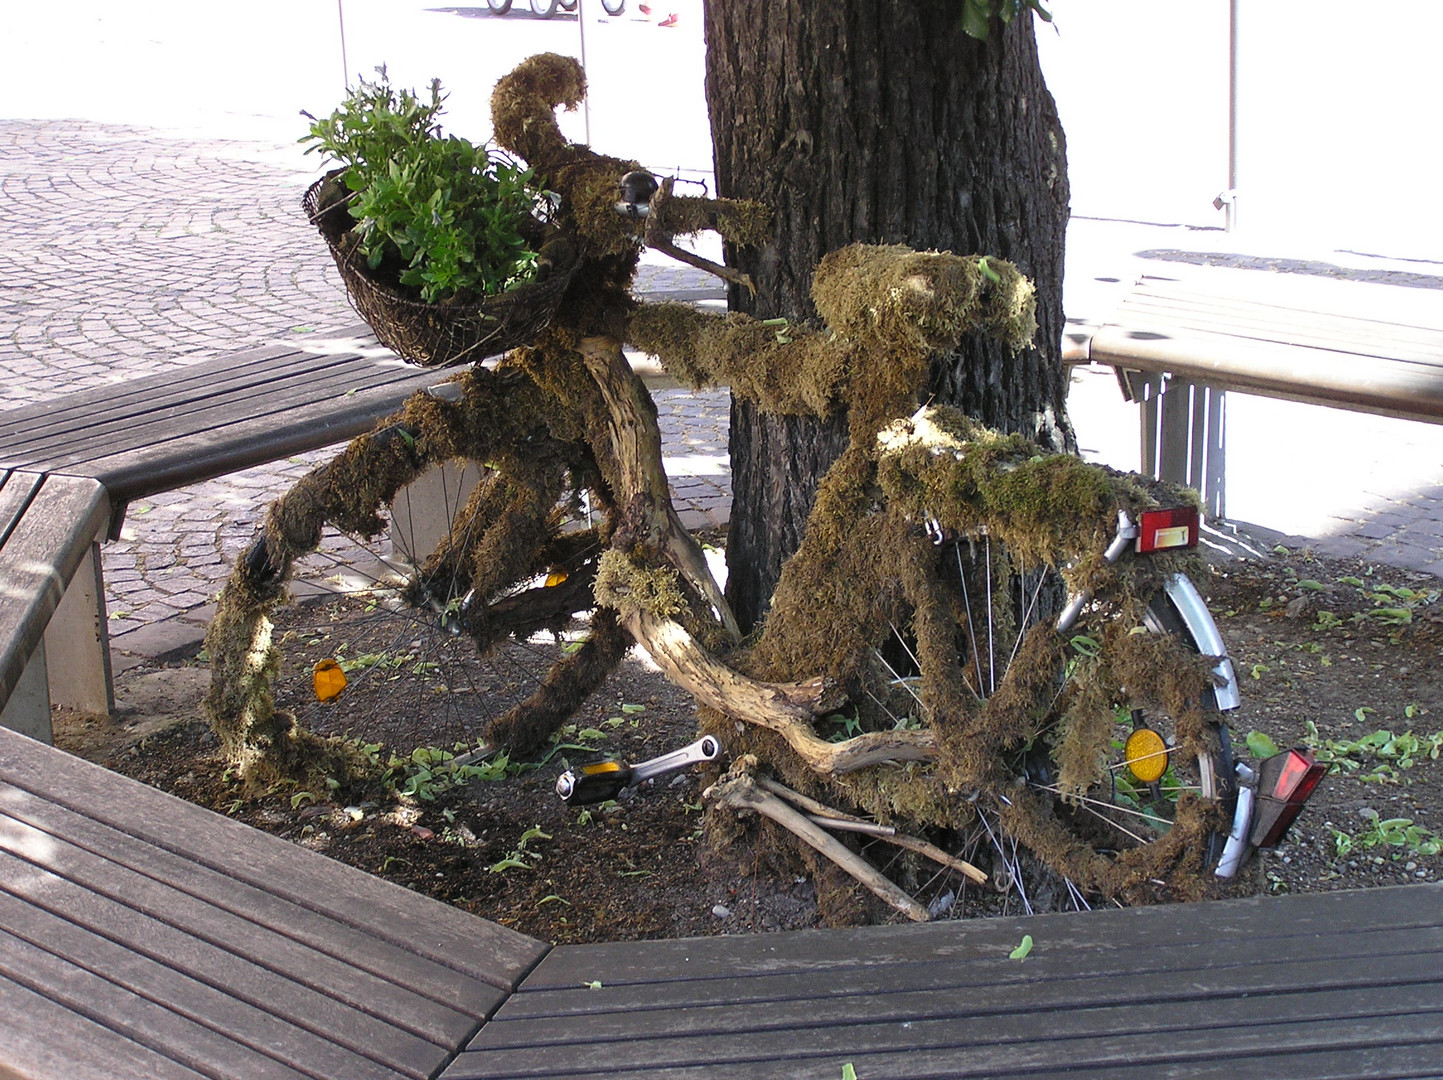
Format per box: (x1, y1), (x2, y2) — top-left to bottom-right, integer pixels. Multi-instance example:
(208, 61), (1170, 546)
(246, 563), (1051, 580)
(443, 885), (1443, 1080)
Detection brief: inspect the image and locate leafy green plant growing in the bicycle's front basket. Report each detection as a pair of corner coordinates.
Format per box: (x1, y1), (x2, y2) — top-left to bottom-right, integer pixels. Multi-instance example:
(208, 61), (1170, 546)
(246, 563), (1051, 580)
(300, 66), (545, 303)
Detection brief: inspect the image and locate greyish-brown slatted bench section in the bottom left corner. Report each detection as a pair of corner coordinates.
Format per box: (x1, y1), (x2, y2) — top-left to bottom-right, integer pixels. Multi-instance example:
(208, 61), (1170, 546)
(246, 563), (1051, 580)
(0, 729), (547, 1080)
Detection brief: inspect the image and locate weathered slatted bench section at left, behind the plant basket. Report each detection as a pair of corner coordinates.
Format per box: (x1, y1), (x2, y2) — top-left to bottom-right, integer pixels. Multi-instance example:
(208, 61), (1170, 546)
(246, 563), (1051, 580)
(0, 326), (444, 738)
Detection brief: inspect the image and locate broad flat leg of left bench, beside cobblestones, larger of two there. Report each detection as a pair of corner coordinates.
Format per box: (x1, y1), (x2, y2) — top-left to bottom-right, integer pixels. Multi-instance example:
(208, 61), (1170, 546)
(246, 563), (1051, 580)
(45, 543), (115, 715)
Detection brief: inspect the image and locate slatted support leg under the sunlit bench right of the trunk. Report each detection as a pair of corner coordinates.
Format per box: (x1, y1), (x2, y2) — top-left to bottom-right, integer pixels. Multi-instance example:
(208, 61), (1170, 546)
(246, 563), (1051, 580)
(1121, 371), (1227, 518)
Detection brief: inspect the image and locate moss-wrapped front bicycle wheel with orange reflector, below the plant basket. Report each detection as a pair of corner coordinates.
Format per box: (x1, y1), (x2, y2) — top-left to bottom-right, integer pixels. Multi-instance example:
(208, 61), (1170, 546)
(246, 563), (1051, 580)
(208, 377), (629, 759)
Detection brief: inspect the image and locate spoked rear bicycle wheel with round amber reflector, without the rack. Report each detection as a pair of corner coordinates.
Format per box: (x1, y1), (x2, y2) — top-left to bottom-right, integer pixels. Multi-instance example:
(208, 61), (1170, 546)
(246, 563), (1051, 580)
(869, 536), (1232, 901)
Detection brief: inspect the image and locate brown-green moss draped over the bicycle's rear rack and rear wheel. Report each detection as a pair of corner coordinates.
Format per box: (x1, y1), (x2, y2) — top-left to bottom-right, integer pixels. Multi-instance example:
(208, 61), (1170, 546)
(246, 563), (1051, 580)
(709, 409), (1215, 898)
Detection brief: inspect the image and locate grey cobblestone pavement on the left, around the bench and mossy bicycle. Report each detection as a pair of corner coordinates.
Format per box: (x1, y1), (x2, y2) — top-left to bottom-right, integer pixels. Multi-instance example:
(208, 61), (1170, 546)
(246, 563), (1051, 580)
(0, 120), (730, 651)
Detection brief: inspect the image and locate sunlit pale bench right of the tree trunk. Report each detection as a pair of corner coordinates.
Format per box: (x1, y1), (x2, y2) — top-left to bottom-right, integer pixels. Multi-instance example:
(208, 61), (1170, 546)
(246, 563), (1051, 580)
(1065, 267), (1443, 517)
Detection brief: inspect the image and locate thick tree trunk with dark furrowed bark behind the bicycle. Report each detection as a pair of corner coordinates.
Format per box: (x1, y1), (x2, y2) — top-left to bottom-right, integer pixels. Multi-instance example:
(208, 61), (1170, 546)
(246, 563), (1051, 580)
(706, 0), (1074, 628)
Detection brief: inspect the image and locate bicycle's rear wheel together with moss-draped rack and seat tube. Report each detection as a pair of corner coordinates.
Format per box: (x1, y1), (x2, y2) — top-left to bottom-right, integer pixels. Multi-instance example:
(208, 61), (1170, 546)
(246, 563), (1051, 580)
(750, 427), (1235, 900)
